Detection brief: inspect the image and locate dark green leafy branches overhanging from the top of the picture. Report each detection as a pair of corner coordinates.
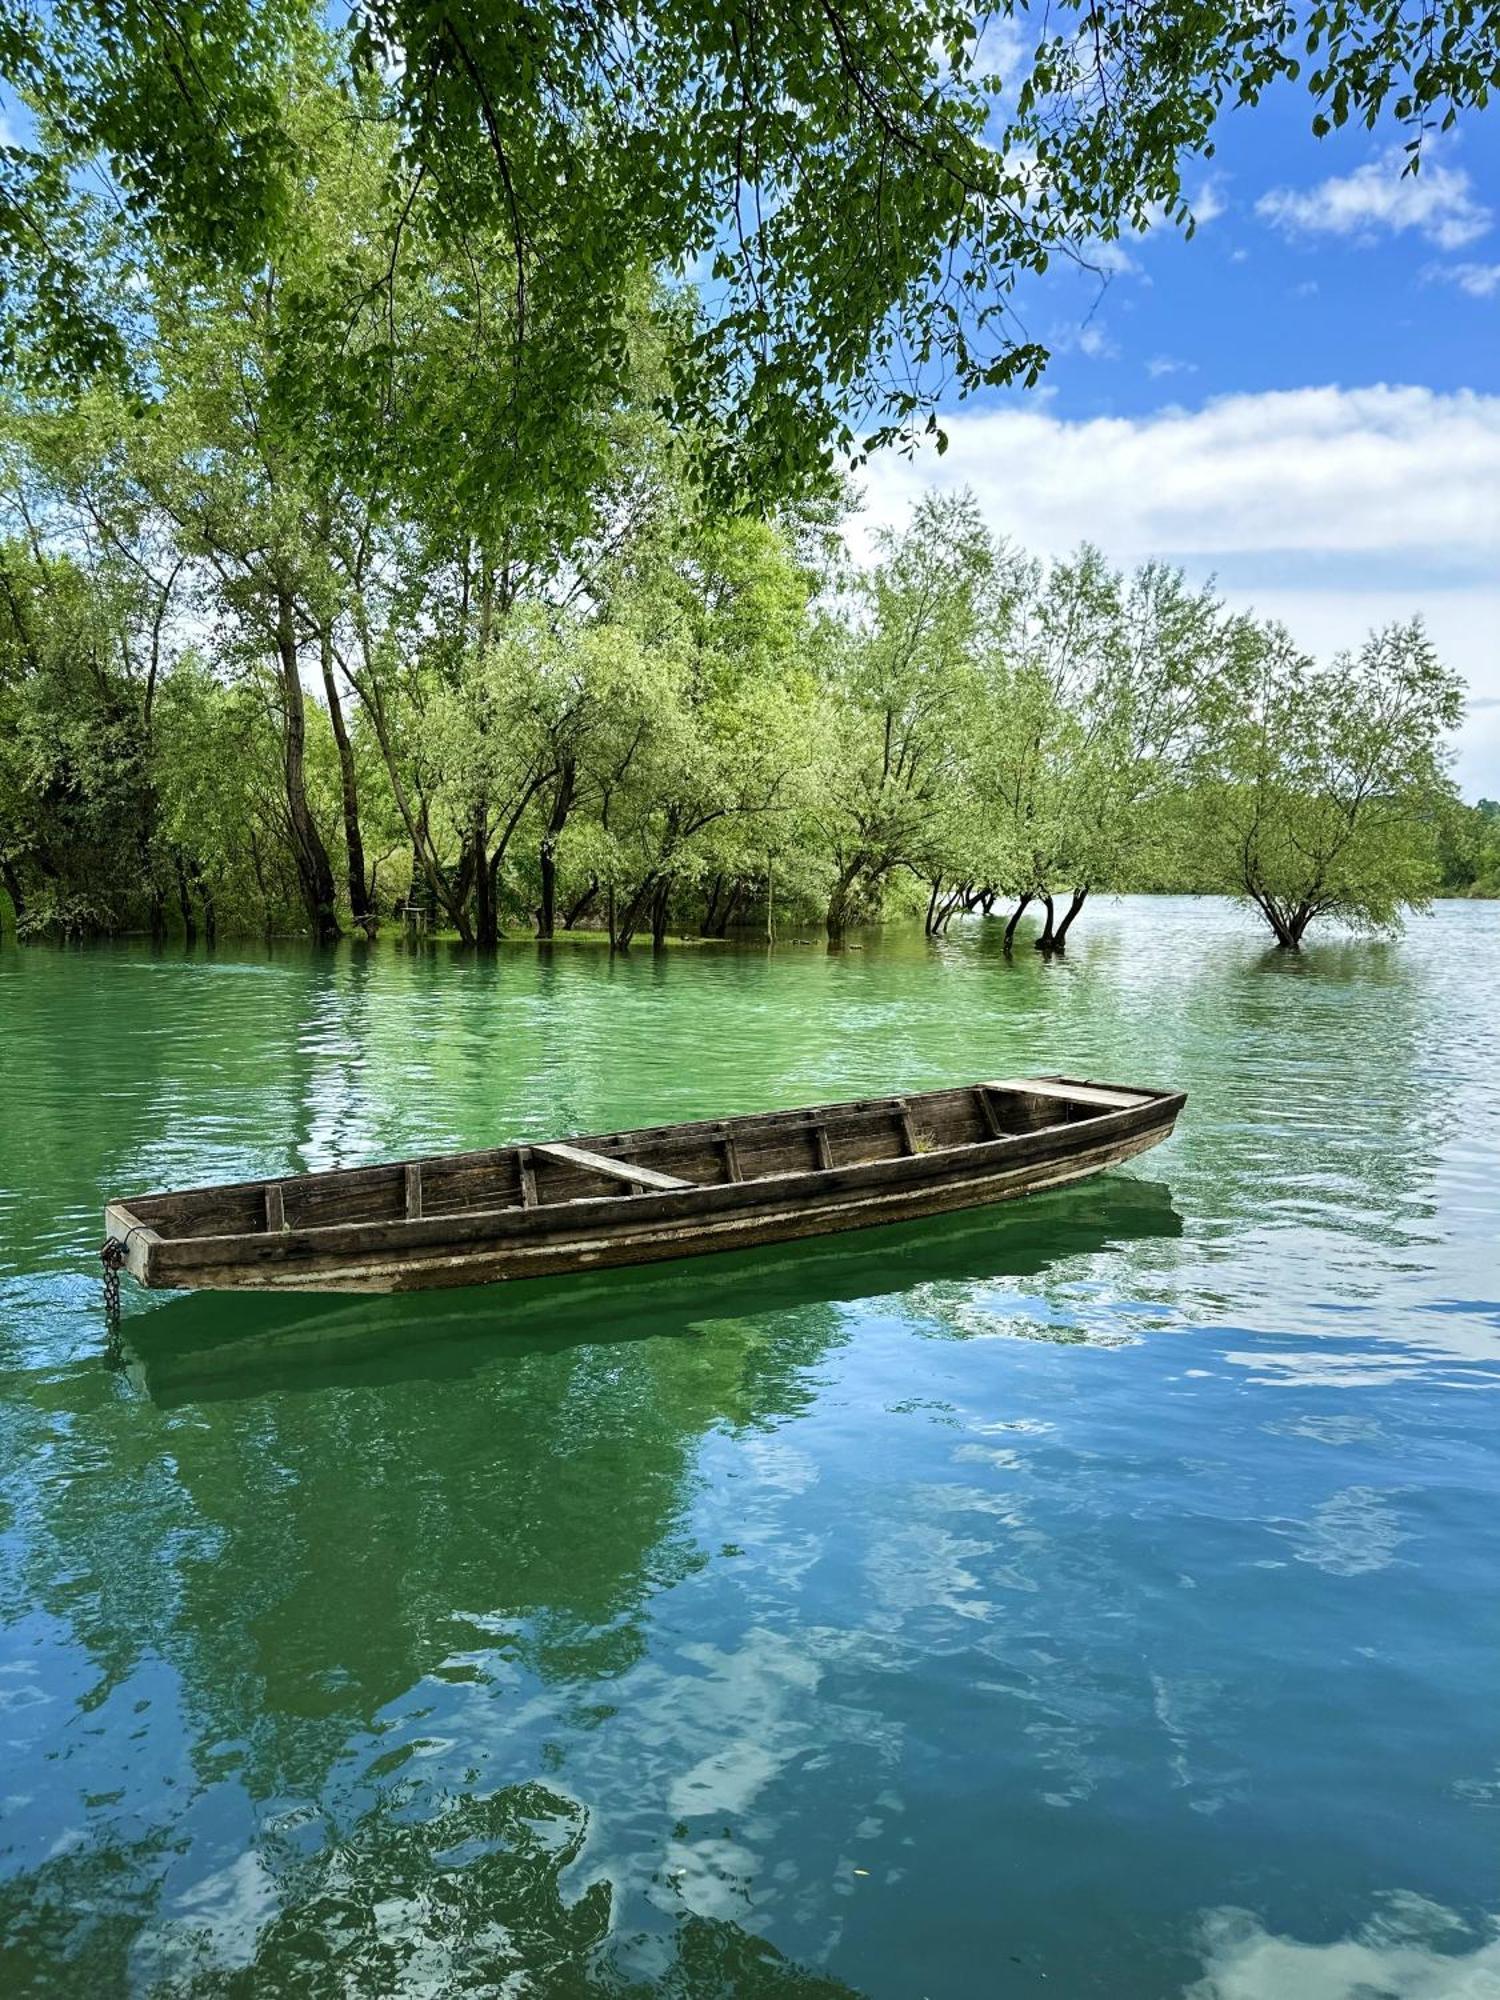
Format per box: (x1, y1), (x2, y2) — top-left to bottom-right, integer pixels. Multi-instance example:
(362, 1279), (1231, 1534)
(0, 0), (1500, 502)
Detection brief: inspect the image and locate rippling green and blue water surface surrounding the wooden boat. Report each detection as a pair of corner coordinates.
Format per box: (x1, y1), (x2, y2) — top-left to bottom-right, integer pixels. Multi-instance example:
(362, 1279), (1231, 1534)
(0, 900), (1500, 2000)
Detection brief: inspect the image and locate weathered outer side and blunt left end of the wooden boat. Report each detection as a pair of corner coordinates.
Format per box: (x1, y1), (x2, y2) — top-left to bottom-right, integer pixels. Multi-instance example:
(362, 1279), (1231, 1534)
(106, 1094), (1182, 1294)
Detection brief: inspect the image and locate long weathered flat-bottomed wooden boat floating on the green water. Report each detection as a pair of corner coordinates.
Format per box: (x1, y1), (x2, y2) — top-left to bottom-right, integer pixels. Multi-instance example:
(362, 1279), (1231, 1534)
(104, 1076), (1184, 1292)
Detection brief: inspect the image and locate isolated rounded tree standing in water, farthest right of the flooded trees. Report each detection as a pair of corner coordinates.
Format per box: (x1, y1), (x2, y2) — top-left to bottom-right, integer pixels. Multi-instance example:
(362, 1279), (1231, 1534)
(1192, 620), (1462, 952)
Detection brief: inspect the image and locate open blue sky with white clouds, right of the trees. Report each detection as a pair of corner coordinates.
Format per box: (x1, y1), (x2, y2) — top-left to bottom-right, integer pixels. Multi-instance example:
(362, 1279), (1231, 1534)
(856, 88), (1500, 798)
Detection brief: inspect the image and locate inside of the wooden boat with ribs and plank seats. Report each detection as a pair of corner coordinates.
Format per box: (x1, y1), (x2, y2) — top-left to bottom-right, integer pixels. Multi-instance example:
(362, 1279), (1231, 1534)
(128, 1078), (1156, 1240)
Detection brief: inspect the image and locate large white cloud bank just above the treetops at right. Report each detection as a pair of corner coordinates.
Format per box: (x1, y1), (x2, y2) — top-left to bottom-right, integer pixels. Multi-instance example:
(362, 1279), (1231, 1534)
(850, 386), (1500, 796)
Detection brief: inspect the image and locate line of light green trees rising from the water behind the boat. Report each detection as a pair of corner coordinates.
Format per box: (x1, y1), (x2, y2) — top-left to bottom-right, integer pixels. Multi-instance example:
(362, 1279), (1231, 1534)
(0, 42), (1494, 950)
